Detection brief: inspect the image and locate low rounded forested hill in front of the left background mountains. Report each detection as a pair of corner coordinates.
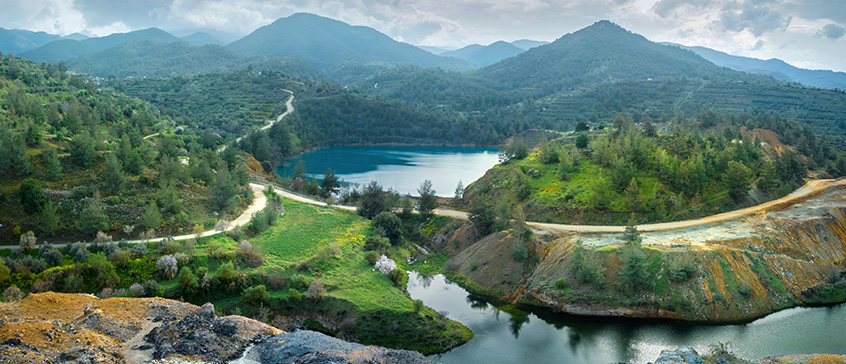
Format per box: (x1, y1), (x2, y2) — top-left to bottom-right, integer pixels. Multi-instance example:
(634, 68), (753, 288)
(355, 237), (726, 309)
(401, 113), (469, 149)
(67, 40), (325, 79)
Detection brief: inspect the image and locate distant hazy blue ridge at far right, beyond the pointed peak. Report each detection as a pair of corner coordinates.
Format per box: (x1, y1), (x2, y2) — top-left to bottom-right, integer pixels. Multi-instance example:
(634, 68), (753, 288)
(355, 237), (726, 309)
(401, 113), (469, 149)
(676, 45), (846, 90)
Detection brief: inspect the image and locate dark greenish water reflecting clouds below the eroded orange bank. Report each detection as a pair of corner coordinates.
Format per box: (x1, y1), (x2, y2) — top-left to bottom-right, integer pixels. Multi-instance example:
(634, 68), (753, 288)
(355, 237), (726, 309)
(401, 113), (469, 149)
(408, 272), (846, 364)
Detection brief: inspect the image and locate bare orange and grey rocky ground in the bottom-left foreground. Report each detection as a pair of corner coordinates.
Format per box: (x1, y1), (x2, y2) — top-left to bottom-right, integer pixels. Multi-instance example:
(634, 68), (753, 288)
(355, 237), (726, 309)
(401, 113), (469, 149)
(0, 292), (430, 364)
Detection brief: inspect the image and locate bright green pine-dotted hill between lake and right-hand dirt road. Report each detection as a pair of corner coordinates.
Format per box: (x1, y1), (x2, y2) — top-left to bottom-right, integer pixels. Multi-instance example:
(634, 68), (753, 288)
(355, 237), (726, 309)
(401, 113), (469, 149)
(462, 111), (846, 229)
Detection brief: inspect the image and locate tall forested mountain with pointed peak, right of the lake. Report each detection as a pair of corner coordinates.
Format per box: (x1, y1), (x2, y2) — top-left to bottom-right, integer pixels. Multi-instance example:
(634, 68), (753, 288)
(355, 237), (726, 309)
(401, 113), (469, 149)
(476, 20), (755, 96)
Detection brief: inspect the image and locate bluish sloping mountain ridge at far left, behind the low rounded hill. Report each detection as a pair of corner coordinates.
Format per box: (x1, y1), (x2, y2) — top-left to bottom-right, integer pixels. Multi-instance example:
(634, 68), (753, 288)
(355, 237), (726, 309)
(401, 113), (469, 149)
(20, 28), (179, 63)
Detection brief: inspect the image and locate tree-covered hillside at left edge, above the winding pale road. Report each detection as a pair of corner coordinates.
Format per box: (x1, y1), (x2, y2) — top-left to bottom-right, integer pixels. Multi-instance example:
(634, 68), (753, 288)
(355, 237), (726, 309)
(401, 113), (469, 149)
(0, 56), (252, 241)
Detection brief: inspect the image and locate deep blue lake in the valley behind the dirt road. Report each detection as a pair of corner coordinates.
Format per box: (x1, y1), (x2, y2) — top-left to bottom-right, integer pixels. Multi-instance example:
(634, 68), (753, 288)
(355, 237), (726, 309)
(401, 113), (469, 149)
(276, 146), (498, 197)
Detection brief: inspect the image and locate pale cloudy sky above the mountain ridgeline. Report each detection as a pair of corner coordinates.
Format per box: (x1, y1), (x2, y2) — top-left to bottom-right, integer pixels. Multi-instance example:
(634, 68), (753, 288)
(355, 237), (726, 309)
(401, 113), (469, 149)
(0, 0), (846, 71)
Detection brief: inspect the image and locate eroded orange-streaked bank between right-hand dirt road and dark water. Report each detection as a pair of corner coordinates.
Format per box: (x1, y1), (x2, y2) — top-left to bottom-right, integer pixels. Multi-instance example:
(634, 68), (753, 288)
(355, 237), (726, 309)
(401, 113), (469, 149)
(445, 185), (846, 322)
